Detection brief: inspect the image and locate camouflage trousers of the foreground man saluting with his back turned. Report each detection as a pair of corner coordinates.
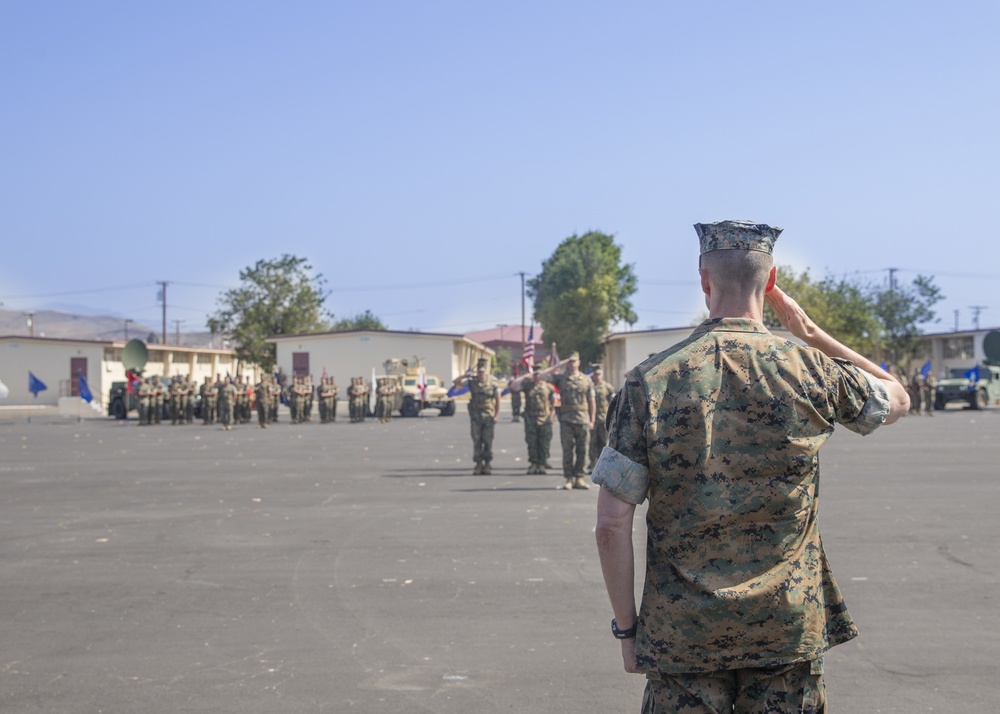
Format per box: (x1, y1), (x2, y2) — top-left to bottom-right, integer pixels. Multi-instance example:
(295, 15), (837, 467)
(642, 658), (826, 714)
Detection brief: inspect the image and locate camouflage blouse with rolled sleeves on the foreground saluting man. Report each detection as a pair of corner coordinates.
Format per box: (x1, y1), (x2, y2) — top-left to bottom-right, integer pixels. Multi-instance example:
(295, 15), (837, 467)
(594, 318), (888, 673)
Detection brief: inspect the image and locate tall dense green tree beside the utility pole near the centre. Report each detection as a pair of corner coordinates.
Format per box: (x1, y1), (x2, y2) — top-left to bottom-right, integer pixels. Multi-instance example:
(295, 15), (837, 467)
(528, 231), (637, 364)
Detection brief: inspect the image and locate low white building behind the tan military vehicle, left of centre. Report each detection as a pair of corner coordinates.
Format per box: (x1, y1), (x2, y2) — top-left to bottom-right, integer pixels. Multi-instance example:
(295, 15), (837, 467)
(267, 330), (493, 386)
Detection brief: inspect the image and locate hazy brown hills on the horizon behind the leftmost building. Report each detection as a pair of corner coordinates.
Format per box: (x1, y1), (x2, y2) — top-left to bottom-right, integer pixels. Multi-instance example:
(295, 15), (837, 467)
(0, 308), (222, 347)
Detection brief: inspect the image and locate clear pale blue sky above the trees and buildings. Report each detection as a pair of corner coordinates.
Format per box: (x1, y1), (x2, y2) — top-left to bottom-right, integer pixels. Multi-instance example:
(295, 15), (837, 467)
(0, 0), (1000, 333)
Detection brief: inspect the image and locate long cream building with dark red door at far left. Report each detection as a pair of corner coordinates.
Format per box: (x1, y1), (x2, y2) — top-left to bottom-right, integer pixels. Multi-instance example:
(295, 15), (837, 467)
(0, 335), (257, 413)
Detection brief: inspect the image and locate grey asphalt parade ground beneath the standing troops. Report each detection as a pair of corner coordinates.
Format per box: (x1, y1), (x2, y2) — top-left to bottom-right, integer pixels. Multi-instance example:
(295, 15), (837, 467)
(0, 403), (1000, 714)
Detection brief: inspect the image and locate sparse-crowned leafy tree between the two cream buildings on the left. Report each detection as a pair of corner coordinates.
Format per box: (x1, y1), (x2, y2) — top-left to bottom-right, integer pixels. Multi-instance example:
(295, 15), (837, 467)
(208, 253), (328, 372)
